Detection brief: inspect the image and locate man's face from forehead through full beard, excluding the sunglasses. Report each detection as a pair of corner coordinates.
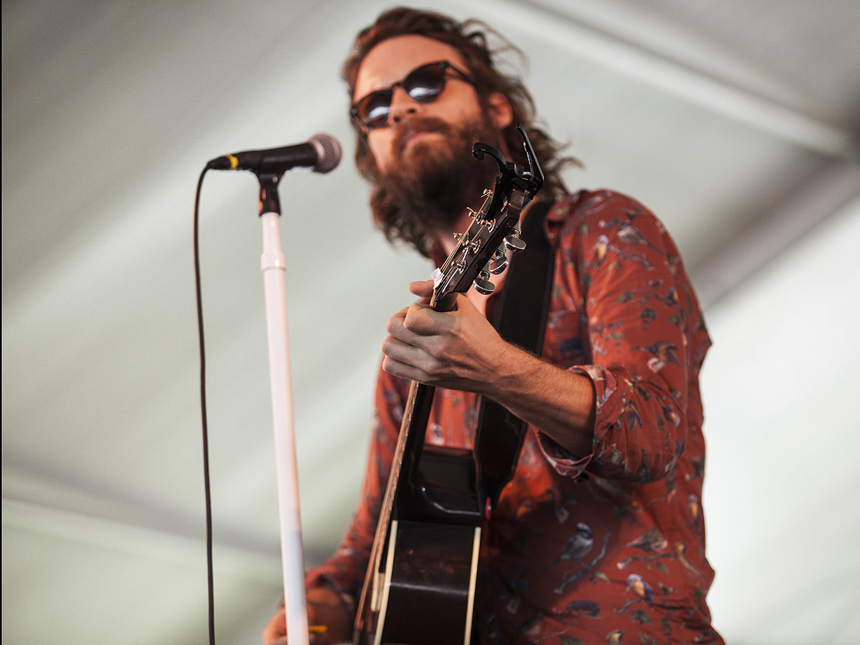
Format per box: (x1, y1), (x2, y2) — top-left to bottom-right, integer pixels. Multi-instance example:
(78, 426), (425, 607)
(353, 31), (513, 239)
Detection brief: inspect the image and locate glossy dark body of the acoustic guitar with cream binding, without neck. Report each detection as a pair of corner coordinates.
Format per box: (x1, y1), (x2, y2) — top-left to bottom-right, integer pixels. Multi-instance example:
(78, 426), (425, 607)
(356, 447), (481, 645)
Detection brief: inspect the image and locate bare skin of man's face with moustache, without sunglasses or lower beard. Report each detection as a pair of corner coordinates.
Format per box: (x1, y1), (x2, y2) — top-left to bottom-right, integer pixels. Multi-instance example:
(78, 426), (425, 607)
(353, 35), (512, 175)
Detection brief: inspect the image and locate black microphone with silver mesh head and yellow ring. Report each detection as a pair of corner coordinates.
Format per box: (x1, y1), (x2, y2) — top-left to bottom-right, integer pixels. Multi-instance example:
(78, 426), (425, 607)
(206, 134), (341, 174)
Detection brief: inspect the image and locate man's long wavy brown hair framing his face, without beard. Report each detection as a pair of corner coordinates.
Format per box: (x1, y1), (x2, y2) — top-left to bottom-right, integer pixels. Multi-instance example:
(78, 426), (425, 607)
(342, 7), (580, 257)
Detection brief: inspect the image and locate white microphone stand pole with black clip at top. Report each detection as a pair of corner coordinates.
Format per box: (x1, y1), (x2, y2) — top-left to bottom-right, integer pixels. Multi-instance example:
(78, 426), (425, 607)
(258, 174), (308, 645)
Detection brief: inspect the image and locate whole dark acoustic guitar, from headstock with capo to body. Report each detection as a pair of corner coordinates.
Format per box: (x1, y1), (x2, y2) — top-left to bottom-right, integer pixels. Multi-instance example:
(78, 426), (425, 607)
(355, 126), (543, 645)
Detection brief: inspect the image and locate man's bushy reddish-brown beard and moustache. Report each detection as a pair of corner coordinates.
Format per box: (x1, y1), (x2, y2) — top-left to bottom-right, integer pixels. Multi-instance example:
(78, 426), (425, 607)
(371, 111), (502, 247)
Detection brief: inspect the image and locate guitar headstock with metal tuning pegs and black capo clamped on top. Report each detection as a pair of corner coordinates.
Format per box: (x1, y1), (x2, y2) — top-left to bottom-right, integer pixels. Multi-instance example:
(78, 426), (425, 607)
(430, 125), (544, 311)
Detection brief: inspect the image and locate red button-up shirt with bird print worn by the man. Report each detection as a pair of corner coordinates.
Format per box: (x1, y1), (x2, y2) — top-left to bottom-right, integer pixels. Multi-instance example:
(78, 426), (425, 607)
(308, 191), (723, 645)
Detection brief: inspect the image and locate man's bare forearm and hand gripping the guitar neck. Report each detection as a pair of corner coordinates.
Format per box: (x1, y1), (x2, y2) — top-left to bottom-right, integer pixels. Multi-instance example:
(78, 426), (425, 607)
(382, 281), (594, 457)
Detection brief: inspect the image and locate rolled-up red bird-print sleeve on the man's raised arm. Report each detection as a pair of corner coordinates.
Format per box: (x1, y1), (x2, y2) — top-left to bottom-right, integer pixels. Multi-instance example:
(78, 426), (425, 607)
(538, 192), (709, 483)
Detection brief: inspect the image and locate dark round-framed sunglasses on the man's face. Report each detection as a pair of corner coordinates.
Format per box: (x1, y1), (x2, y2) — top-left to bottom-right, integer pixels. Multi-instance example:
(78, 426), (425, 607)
(349, 60), (475, 131)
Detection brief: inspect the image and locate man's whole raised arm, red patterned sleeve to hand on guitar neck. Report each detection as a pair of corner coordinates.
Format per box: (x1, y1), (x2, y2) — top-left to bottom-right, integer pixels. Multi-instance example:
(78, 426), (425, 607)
(383, 193), (709, 481)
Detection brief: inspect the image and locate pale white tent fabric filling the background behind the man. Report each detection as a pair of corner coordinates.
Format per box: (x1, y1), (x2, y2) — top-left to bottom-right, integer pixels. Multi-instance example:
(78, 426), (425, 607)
(2, 0), (860, 645)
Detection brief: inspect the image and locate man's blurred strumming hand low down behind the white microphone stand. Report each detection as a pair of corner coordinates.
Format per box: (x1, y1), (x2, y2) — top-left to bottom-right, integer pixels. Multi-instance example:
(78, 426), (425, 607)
(262, 587), (353, 645)
